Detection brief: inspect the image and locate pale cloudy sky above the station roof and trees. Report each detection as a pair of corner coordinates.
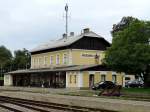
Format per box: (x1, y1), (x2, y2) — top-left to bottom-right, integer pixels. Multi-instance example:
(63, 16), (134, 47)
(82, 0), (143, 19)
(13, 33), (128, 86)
(0, 0), (150, 52)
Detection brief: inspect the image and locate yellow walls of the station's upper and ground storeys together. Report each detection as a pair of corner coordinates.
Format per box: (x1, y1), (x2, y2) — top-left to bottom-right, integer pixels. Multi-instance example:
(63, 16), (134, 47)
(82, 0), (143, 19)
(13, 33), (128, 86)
(31, 49), (123, 88)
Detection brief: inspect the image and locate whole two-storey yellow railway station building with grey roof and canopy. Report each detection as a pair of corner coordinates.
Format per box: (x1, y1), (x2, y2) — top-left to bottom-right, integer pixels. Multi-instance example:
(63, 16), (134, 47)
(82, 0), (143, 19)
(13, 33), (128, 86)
(4, 28), (125, 88)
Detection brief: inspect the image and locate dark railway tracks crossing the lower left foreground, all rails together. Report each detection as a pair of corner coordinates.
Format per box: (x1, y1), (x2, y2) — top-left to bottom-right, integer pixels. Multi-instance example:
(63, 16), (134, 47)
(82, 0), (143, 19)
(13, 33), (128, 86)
(0, 96), (115, 112)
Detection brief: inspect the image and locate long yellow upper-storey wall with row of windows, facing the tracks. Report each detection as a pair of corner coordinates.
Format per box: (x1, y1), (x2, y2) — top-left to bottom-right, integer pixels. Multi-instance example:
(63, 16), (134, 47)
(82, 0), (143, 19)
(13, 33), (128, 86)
(31, 50), (69, 69)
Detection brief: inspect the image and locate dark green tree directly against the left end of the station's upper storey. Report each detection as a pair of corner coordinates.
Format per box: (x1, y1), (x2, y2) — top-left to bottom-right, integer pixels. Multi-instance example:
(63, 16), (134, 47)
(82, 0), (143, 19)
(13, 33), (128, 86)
(13, 49), (31, 70)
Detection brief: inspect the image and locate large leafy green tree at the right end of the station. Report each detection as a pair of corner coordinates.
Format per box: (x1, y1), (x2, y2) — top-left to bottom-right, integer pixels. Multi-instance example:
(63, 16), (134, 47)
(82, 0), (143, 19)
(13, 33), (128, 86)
(105, 18), (150, 87)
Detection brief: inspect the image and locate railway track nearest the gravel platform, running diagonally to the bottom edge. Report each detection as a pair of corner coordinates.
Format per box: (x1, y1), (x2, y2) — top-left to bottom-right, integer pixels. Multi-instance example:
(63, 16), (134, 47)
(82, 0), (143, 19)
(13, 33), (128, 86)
(0, 96), (116, 112)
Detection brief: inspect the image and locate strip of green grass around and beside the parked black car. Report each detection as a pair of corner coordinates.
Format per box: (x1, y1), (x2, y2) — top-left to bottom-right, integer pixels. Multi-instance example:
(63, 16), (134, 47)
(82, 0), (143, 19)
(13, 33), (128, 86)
(60, 88), (150, 101)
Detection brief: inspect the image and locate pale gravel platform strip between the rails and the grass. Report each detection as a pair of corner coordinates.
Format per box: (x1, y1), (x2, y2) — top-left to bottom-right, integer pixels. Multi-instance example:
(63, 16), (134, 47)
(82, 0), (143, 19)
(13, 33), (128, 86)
(0, 88), (150, 112)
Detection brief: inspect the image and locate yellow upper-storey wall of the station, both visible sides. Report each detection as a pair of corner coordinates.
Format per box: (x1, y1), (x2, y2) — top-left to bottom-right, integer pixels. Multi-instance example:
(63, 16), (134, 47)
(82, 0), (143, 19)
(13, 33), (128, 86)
(31, 49), (105, 69)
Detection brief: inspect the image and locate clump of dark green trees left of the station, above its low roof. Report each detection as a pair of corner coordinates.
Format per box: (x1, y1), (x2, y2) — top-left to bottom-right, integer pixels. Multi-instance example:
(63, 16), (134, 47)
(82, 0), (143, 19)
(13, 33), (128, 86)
(0, 46), (31, 76)
